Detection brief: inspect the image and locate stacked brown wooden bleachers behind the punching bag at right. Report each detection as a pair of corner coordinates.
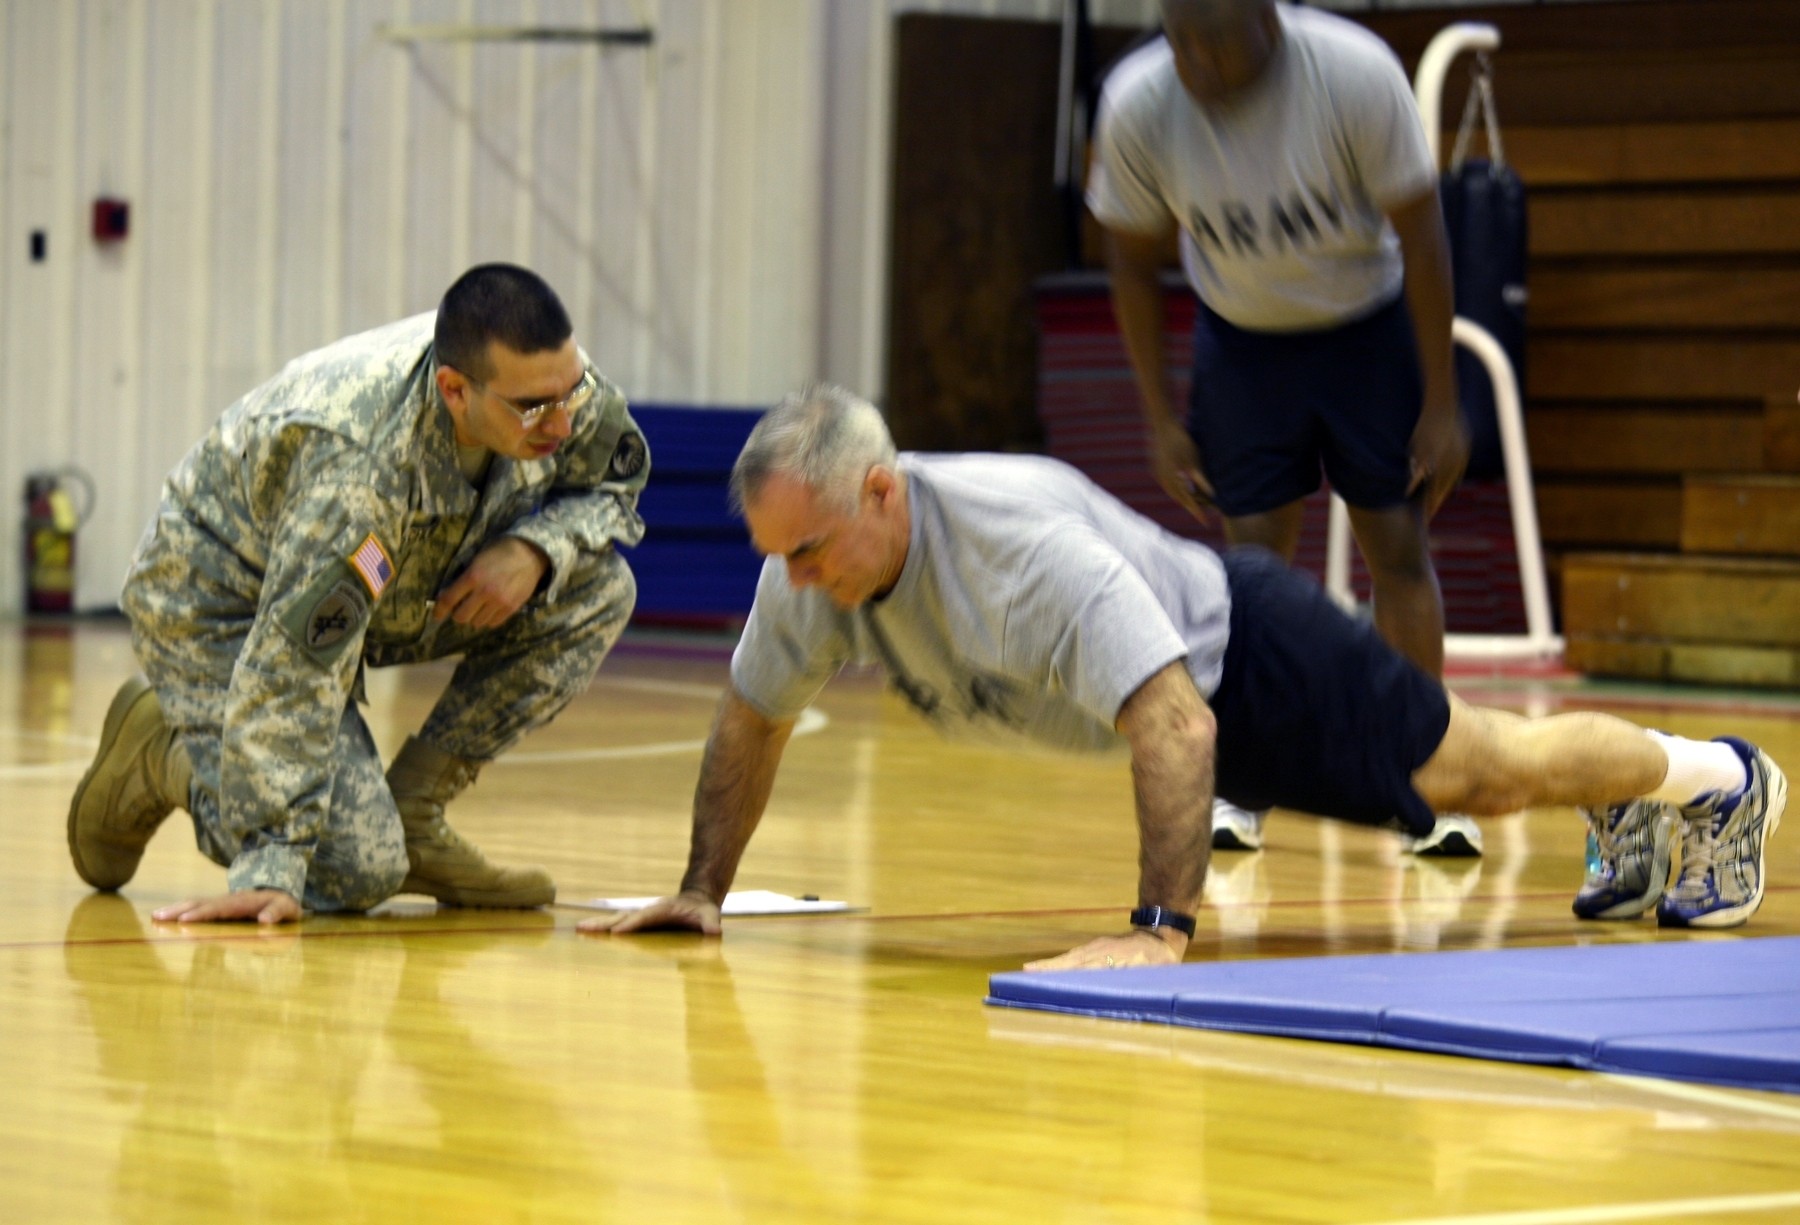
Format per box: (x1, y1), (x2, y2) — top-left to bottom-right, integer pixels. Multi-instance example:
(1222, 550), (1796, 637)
(1368, 0), (1800, 685)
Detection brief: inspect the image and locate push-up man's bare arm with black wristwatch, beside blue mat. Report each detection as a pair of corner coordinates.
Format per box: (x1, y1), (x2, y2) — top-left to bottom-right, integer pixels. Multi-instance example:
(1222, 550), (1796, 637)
(1026, 660), (1219, 970)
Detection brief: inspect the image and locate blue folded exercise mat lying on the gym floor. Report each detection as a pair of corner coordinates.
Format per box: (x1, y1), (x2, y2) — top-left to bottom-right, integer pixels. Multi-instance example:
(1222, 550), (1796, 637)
(988, 937), (1800, 1094)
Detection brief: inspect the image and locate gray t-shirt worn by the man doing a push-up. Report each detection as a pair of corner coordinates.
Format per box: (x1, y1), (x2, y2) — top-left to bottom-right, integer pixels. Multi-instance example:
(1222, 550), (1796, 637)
(731, 453), (1231, 750)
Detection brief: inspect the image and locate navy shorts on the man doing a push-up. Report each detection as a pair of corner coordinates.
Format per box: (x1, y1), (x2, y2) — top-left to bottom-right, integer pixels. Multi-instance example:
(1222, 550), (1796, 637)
(1211, 549), (1451, 836)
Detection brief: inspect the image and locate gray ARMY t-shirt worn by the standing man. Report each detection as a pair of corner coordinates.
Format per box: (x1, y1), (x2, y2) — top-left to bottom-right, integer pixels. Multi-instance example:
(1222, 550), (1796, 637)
(1087, 5), (1436, 331)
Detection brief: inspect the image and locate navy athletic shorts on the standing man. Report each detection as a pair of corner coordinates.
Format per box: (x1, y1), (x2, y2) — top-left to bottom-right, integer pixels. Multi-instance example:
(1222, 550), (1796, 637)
(1188, 297), (1424, 516)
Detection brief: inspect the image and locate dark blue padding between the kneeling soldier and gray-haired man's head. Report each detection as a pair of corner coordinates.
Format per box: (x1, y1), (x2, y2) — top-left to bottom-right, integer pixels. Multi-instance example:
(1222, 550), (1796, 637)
(626, 405), (763, 622)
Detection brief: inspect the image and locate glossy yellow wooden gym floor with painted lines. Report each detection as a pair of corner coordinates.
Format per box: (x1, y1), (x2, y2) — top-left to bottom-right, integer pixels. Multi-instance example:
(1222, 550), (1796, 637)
(0, 622), (1800, 1225)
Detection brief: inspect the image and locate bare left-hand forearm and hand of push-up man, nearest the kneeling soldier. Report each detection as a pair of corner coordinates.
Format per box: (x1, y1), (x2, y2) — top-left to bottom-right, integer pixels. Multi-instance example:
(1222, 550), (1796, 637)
(576, 689), (794, 935)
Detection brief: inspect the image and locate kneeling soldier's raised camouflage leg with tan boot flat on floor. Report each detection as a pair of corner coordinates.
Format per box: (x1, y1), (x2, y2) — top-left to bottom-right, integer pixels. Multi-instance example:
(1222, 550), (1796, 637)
(371, 549), (637, 907)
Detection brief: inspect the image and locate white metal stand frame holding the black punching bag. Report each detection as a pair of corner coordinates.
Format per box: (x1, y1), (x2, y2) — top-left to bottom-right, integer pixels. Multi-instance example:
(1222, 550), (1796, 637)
(1325, 22), (1562, 660)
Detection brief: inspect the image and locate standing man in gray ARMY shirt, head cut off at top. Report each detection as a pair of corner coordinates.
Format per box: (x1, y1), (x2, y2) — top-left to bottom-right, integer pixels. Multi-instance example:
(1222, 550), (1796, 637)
(1087, 0), (1480, 854)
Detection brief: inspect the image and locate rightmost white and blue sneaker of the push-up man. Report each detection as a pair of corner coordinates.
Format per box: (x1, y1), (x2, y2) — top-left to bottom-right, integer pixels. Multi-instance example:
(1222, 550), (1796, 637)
(1656, 736), (1787, 928)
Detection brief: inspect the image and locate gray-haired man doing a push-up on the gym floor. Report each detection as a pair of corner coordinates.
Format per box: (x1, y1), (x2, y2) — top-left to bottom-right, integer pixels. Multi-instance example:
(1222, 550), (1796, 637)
(580, 387), (1787, 970)
